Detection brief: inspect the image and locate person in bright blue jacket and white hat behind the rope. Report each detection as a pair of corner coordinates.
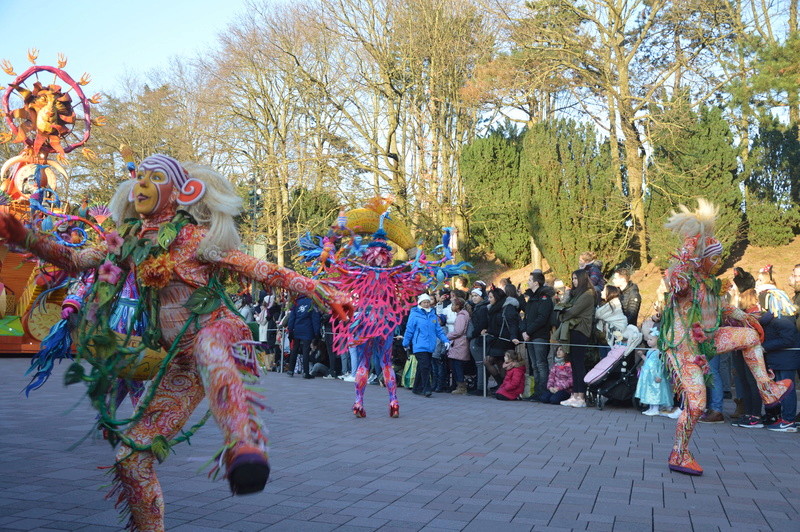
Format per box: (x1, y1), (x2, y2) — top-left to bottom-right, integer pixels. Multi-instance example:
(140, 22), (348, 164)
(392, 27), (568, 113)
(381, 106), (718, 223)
(403, 294), (450, 397)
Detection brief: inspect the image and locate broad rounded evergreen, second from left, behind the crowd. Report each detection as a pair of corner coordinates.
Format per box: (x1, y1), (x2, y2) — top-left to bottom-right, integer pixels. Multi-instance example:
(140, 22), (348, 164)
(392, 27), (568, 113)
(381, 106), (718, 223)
(520, 120), (630, 278)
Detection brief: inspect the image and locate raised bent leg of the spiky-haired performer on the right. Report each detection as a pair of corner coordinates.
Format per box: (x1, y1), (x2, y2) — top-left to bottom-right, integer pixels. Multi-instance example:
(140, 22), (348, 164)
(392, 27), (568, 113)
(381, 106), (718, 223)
(714, 327), (794, 407)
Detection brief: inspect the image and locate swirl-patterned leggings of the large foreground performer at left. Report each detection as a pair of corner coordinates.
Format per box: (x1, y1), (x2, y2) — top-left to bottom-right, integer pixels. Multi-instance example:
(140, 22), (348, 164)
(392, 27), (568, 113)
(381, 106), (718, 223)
(115, 318), (267, 531)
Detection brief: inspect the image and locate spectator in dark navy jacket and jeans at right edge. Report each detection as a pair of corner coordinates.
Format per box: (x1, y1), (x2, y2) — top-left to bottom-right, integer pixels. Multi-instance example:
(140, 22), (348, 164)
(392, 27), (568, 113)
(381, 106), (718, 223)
(758, 312), (800, 432)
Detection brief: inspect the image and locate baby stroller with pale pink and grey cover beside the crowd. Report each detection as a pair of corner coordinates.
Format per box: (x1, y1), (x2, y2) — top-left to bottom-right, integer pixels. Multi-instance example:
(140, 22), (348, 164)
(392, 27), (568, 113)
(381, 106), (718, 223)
(583, 325), (642, 410)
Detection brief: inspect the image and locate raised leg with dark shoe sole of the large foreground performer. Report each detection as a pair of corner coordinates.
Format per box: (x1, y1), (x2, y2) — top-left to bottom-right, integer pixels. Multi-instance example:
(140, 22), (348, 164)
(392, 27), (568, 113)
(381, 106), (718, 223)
(194, 318), (269, 495)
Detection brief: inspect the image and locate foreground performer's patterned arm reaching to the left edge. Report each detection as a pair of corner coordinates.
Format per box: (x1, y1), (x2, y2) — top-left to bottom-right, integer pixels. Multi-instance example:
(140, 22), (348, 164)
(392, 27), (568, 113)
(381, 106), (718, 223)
(0, 214), (107, 276)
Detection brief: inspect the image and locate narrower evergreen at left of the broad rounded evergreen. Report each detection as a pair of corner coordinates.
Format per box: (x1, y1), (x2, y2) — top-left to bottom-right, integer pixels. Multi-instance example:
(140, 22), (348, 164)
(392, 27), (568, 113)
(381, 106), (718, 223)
(460, 131), (530, 268)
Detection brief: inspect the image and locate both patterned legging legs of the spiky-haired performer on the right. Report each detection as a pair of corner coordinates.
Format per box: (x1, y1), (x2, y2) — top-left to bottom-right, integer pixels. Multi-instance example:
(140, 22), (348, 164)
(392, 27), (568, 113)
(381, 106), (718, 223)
(668, 320), (783, 455)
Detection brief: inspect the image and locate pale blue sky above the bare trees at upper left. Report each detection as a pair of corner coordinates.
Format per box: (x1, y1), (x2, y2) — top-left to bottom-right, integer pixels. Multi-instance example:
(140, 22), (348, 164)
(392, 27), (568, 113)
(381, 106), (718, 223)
(0, 0), (246, 95)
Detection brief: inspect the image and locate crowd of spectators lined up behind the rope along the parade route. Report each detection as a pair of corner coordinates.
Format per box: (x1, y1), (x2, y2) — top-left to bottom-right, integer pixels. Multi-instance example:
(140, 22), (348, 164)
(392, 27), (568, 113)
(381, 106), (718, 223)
(236, 258), (800, 432)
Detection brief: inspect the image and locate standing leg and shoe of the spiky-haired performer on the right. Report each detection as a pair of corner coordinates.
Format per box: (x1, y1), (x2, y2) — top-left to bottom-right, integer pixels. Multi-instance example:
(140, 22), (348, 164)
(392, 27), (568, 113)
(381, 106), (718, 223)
(669, 360), (706, 475)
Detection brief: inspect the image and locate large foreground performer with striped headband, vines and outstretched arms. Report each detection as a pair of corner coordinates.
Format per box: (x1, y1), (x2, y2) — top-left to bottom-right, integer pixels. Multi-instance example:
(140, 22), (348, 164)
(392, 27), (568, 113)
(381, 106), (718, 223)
(0, 155), (350, 531)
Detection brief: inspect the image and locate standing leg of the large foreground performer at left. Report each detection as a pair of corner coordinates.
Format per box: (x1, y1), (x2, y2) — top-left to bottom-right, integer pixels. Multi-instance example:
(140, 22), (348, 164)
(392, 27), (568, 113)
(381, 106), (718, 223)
(109, 355), (203, 531)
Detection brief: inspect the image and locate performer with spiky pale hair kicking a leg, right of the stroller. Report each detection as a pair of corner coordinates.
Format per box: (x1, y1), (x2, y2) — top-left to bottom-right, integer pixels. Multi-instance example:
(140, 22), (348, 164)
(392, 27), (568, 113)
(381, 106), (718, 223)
(659, 199), (794, 475)
